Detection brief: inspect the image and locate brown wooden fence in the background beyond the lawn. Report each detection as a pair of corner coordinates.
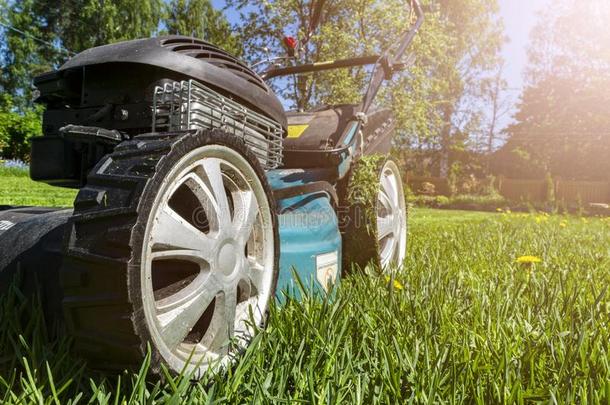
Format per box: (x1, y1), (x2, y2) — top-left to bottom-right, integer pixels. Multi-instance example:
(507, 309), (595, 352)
(407, 175), (610, 204)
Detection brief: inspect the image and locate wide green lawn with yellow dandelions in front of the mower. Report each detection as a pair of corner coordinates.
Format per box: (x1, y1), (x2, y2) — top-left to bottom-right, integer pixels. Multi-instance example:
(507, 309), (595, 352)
(0, 176), (610, 404)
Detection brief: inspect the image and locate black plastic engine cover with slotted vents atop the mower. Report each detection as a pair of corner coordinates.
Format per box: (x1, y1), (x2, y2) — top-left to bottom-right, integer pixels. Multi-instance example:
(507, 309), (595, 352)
(30, 36), (287, 188)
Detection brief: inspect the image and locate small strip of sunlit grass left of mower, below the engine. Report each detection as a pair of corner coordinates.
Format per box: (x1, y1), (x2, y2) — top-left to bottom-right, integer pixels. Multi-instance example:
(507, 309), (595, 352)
(0, 167), (76, 207)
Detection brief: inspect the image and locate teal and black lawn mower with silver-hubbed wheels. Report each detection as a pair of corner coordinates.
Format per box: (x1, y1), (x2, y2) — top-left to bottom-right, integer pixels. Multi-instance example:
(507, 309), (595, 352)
(0, 1), (423, 374)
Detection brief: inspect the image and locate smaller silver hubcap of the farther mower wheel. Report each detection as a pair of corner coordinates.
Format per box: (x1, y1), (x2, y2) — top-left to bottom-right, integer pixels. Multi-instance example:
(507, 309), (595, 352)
(377, 160), (407, 270)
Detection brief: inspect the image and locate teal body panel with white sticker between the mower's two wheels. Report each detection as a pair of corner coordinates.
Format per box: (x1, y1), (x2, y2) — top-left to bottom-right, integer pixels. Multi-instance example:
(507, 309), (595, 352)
(267, 169), (341, 301)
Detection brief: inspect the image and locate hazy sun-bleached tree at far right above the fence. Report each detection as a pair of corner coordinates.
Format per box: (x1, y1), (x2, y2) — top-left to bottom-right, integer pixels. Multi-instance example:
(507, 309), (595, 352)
(496, 0), (610, 180)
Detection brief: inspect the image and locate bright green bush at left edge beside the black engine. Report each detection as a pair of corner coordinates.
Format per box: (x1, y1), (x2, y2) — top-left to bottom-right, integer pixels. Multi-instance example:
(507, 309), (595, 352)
(0, 96), (42, 161)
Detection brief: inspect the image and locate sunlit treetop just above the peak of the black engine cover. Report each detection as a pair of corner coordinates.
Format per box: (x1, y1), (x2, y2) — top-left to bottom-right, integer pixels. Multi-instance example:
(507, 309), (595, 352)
(164, 0), (242, 56)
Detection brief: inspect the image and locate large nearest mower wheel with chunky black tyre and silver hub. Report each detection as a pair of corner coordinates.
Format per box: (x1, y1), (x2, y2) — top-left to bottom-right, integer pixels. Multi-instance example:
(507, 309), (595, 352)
(62, 131), (278, 375)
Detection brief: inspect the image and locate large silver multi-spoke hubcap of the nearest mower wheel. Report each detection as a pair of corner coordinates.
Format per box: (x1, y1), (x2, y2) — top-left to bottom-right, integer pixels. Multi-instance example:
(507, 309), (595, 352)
(142, 145), (274, 371)
